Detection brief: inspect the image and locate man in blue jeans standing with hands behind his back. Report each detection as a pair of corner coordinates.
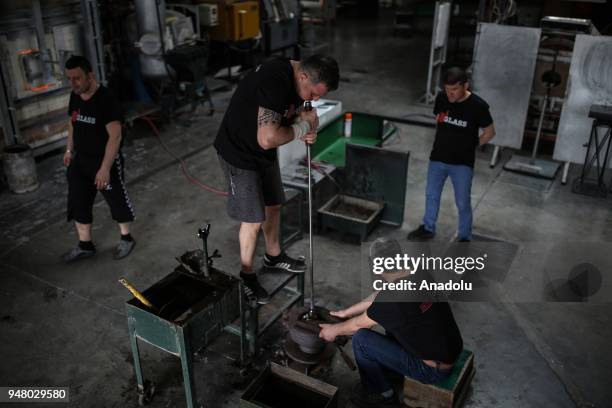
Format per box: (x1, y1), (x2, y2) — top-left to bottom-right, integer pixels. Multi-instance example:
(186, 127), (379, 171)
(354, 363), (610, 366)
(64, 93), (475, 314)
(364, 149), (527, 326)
(408, 67), (495, 242)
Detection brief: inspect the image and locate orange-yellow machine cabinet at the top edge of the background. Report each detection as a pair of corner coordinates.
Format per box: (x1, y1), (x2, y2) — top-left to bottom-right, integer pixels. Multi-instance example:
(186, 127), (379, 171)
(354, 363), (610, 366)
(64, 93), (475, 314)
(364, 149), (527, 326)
(198, 0), (259, 41)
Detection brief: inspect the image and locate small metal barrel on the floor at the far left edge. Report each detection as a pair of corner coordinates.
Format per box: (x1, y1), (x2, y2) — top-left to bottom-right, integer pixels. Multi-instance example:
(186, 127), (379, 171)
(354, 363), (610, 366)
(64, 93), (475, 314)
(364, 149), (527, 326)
(2, 144), (38, 194)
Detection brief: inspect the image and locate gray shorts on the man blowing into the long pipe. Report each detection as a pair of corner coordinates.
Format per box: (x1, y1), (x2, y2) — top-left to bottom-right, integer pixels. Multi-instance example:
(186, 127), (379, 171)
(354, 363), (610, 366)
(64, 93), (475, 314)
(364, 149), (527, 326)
(217, 155), (285, 223)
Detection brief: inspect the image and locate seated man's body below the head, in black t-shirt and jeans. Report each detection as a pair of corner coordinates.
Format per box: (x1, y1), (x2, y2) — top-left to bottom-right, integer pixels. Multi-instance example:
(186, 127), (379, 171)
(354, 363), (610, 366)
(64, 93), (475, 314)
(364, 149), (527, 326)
(319, 292), (463, 407)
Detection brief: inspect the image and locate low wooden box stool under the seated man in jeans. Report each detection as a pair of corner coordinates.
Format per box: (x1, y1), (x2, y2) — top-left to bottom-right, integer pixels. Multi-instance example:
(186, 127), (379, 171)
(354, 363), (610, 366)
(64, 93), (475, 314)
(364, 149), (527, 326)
(404, 349), (476, 408)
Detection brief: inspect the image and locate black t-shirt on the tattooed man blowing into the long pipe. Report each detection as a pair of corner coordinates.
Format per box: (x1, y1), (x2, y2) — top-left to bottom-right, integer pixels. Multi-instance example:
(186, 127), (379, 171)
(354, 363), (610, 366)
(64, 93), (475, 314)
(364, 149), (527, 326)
(215, 59), (303, 170)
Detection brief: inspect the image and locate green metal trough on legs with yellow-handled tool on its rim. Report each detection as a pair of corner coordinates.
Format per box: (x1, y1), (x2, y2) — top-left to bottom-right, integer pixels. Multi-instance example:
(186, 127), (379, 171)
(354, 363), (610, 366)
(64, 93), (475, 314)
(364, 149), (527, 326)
(126, 266), (241, 408)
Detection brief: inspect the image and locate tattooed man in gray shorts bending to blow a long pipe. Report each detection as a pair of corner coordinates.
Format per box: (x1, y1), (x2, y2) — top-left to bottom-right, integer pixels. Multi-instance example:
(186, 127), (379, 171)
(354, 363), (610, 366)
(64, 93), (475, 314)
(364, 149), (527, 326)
(215, 55), (339, 304)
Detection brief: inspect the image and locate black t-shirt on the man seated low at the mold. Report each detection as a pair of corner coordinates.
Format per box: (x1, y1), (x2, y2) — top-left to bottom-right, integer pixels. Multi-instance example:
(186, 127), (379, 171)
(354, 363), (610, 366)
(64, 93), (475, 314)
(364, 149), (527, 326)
(367, 298), (463, 364)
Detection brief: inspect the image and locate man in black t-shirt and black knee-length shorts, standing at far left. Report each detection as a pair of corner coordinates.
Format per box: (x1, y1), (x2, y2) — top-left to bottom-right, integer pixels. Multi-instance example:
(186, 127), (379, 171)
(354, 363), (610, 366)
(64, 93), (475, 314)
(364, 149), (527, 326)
(63, 55), (136, 262)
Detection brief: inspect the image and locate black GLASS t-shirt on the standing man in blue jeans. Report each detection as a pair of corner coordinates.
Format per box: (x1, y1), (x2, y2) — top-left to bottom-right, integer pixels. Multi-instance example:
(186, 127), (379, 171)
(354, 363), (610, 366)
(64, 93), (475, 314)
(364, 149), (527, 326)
(429, 92), (493, 167)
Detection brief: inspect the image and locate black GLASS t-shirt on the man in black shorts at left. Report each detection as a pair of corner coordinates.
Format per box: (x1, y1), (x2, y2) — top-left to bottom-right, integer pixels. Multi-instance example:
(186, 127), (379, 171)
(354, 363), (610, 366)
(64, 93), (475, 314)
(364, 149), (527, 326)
(68, 85), (123, 160)
